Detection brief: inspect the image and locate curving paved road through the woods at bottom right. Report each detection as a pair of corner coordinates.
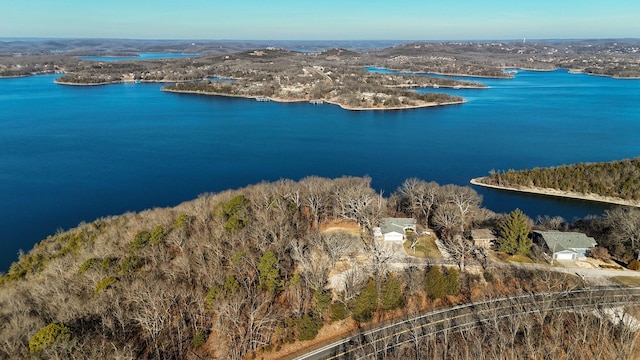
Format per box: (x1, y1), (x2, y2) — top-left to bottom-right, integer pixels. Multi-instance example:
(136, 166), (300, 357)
(296, 287), (640, 360)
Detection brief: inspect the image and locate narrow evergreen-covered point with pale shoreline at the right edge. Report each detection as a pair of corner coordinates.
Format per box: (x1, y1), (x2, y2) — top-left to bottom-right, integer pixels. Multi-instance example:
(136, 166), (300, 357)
(471, 158), (640, 206)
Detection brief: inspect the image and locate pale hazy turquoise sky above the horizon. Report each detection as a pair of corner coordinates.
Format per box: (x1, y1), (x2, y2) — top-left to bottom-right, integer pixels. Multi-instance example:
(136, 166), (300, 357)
(0, 0), (640, 40)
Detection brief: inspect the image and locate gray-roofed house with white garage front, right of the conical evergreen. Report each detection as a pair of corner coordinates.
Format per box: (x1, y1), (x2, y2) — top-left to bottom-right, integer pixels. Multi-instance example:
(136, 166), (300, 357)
(533, 230), (598, 260)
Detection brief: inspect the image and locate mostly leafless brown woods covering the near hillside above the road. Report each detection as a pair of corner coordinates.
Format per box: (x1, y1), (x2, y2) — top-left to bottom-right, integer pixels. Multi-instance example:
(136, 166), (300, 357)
(0, 177), (637, 359)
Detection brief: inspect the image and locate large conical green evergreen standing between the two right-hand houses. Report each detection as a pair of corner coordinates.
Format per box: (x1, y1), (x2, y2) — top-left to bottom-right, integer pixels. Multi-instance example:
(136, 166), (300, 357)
(497, 209), (532, 255)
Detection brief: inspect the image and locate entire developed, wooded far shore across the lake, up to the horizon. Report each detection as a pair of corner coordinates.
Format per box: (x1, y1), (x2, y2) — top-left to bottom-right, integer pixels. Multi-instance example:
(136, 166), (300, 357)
(0, 40), (640, 110)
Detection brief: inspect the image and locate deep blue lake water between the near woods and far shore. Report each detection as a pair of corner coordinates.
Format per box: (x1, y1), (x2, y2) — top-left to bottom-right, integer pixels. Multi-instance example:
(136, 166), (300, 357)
(0, 71), (640, 270)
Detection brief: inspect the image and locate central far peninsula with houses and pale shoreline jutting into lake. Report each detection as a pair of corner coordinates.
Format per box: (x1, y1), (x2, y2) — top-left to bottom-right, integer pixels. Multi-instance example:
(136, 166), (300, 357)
(56, 47), (486, 110)
